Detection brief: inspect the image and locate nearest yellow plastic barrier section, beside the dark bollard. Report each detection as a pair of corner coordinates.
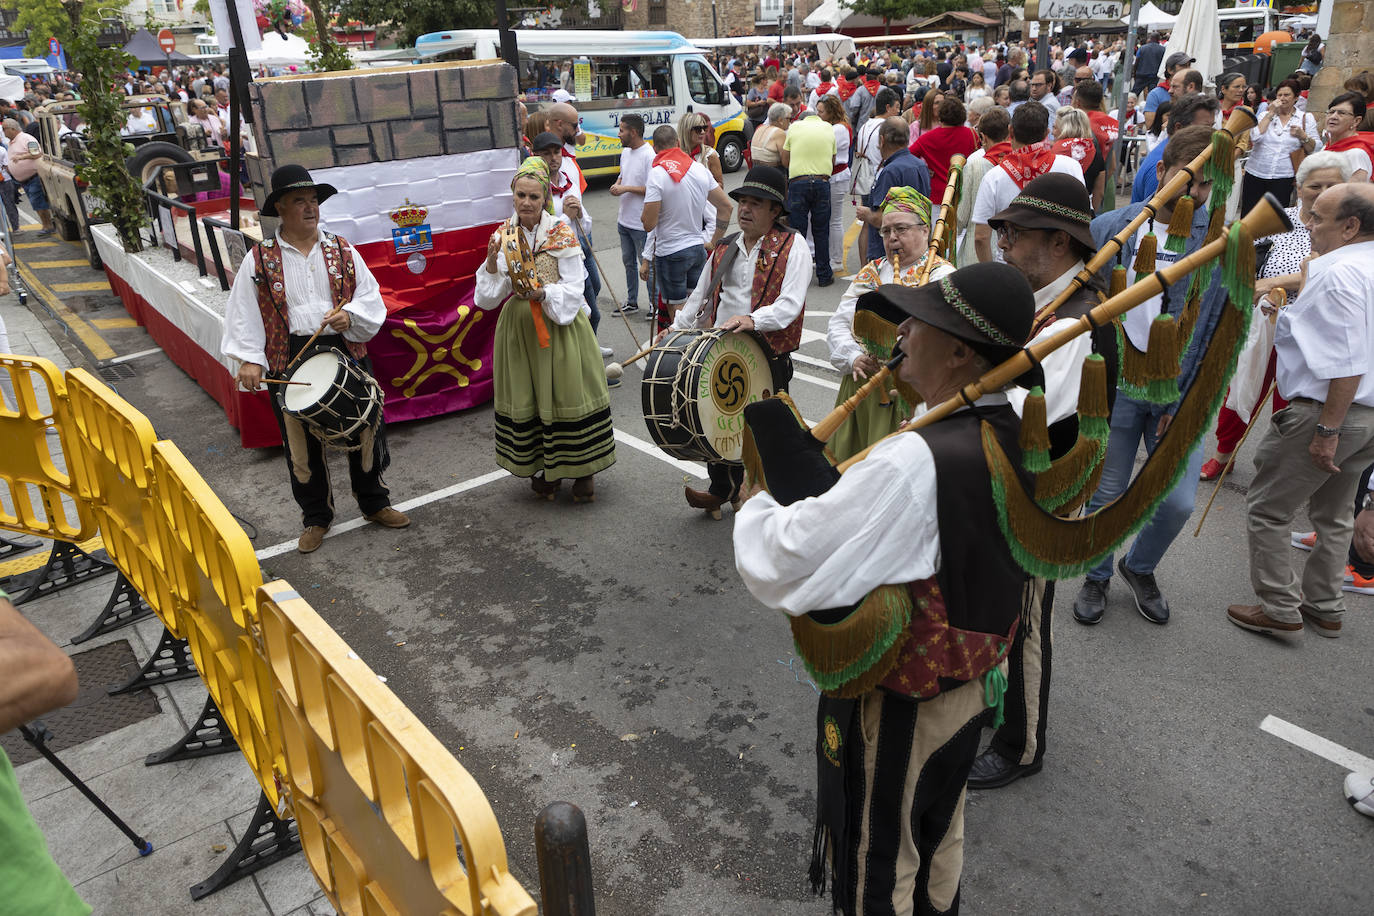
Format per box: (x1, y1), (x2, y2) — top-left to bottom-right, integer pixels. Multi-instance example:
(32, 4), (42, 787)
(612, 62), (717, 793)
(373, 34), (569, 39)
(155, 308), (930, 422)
(258, 581), (537, 916)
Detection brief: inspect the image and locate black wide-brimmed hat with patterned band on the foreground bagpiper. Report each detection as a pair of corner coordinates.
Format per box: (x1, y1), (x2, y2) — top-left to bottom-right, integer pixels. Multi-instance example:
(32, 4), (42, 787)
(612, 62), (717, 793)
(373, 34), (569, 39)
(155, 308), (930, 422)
(857, 261), (1035, 379)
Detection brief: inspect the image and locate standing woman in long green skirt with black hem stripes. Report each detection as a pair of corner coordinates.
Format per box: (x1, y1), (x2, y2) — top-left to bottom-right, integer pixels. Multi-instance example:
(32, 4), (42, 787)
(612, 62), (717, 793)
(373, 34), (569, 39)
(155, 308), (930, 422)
(475, 157), (616, 503)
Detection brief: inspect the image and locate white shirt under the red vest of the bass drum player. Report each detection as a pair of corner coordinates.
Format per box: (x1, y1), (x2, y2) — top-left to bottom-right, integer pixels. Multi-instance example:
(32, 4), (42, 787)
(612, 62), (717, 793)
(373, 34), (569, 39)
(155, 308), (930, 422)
(673, 233), (812, 332)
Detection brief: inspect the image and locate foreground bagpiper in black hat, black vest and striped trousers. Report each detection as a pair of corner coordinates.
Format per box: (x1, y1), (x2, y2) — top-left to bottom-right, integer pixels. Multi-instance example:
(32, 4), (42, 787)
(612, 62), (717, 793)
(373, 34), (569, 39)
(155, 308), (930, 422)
(734, 264), (1035, 916)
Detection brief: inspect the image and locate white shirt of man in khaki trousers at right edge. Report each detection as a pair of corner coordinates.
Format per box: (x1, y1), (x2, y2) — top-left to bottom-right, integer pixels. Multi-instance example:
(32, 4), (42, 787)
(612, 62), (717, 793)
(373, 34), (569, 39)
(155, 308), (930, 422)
(1274, 242), (1374, 407)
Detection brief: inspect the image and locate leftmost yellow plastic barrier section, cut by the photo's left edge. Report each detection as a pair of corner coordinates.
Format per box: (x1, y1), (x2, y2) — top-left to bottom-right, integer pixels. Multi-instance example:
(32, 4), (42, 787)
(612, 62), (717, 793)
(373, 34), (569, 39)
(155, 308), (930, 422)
(0, 354), (99, 542)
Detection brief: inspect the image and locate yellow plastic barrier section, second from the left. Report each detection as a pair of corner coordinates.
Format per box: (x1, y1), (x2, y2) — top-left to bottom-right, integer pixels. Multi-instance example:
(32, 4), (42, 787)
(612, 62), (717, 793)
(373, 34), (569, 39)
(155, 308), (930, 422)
(66, 369), (185, 639)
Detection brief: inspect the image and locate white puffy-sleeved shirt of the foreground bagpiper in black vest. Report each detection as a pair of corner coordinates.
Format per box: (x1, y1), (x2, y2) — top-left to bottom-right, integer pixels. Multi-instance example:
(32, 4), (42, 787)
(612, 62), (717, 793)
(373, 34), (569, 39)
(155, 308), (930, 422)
(734, 393), (1006, 617)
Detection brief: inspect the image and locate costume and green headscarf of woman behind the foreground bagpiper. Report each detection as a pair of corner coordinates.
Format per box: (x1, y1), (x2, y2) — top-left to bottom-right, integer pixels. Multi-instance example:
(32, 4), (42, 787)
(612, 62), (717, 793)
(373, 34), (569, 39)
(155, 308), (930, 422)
(826, 188), (954, 461)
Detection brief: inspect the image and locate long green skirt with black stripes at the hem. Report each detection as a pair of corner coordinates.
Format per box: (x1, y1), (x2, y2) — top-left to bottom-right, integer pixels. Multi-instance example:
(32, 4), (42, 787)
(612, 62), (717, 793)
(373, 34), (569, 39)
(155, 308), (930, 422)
(492, 298), (616, 481)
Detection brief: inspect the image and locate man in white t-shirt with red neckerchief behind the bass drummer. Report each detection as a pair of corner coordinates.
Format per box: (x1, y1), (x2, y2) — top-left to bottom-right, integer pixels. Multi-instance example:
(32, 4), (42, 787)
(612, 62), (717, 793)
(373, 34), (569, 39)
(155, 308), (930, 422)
(640, 124), (734, 324)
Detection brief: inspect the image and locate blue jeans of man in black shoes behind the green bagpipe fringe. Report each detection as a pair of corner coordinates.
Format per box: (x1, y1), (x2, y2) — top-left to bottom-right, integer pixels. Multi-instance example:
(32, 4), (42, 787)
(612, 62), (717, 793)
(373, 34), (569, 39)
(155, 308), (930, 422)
(1088, 391), (1202, 582)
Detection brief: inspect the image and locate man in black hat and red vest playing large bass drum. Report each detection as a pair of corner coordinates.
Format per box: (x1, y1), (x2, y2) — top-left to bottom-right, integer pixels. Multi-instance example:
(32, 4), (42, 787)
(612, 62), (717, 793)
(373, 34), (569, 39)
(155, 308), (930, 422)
(658, 165), (812, 518)
